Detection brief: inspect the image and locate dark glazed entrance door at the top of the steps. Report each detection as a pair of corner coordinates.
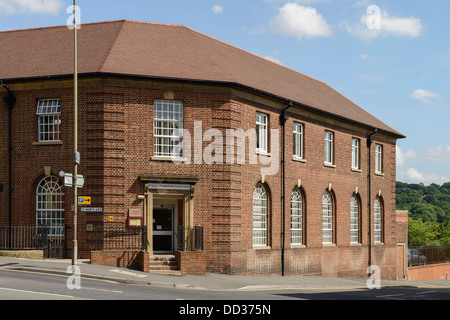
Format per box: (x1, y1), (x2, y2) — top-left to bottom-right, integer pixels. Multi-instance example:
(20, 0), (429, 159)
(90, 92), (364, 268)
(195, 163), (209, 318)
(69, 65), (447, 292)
(153, 205), (175, 254)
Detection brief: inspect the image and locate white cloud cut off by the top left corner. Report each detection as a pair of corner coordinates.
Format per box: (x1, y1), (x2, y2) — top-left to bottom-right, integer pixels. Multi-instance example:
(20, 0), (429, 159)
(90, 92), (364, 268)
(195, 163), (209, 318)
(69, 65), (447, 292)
(0, 0), (63, 14)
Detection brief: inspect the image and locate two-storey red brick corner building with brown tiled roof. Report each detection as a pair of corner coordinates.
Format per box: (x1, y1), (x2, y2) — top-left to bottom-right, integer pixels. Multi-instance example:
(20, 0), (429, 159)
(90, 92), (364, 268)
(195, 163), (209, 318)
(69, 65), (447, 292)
(0, 20), (404, 278)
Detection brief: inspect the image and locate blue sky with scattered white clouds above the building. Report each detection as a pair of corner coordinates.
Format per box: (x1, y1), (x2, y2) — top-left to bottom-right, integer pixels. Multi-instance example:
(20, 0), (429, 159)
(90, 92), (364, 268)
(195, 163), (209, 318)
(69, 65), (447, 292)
(0, 0), (450, 185)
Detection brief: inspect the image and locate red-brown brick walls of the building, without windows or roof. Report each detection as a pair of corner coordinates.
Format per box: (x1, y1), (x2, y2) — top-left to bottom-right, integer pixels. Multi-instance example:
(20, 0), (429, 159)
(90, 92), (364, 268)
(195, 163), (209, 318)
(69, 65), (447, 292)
(0, 79), (397, 278)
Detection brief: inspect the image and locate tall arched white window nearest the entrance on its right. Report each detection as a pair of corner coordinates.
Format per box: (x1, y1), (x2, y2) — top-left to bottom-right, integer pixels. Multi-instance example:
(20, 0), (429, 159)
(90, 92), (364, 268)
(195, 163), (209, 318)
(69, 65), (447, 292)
(253, 183), (267, 247)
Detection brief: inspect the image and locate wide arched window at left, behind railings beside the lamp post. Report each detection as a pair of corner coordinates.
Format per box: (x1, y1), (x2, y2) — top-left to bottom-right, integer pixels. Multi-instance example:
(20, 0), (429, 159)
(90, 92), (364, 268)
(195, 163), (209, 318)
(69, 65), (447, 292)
(36, 176), (64, 236)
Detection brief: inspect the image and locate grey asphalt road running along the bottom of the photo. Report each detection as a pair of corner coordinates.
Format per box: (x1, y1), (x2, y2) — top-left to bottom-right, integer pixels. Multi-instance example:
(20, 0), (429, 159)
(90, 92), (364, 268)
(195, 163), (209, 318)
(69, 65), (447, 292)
(0, 269), (450, 305)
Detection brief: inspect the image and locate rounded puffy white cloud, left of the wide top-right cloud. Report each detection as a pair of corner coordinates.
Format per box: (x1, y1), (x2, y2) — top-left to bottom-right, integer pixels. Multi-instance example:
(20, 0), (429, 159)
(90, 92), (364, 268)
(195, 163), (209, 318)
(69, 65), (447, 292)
(270, 3), (333, 40)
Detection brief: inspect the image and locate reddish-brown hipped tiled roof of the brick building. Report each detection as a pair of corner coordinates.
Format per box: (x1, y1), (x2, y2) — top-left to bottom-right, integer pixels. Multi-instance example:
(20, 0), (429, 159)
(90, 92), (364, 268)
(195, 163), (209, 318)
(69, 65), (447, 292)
(0, 20), (403, 137)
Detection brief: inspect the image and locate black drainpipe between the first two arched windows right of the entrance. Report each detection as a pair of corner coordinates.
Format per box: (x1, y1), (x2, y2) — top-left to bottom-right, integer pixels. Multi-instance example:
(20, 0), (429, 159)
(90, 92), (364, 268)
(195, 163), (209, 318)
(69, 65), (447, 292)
(280, 102), (292, 277)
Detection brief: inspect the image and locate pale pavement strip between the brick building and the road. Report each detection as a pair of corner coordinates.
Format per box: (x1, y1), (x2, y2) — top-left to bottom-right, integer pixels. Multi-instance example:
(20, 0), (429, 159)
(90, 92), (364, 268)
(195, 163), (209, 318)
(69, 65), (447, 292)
(0, 256), (450, 290)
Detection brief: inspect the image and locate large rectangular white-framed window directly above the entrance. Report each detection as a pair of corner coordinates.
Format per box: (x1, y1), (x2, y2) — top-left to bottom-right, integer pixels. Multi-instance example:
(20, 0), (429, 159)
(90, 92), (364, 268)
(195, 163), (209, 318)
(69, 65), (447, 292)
(153, 100), (184, 158)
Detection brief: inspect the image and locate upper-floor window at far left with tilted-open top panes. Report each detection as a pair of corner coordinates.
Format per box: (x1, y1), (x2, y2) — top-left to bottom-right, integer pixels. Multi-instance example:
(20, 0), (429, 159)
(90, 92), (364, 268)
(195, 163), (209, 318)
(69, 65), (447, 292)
(36, 99), (61, 142)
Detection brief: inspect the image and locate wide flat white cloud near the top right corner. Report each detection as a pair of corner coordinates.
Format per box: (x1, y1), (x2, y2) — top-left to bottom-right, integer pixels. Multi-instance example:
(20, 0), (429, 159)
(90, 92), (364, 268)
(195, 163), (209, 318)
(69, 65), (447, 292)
(343, 9), (423, 40)
